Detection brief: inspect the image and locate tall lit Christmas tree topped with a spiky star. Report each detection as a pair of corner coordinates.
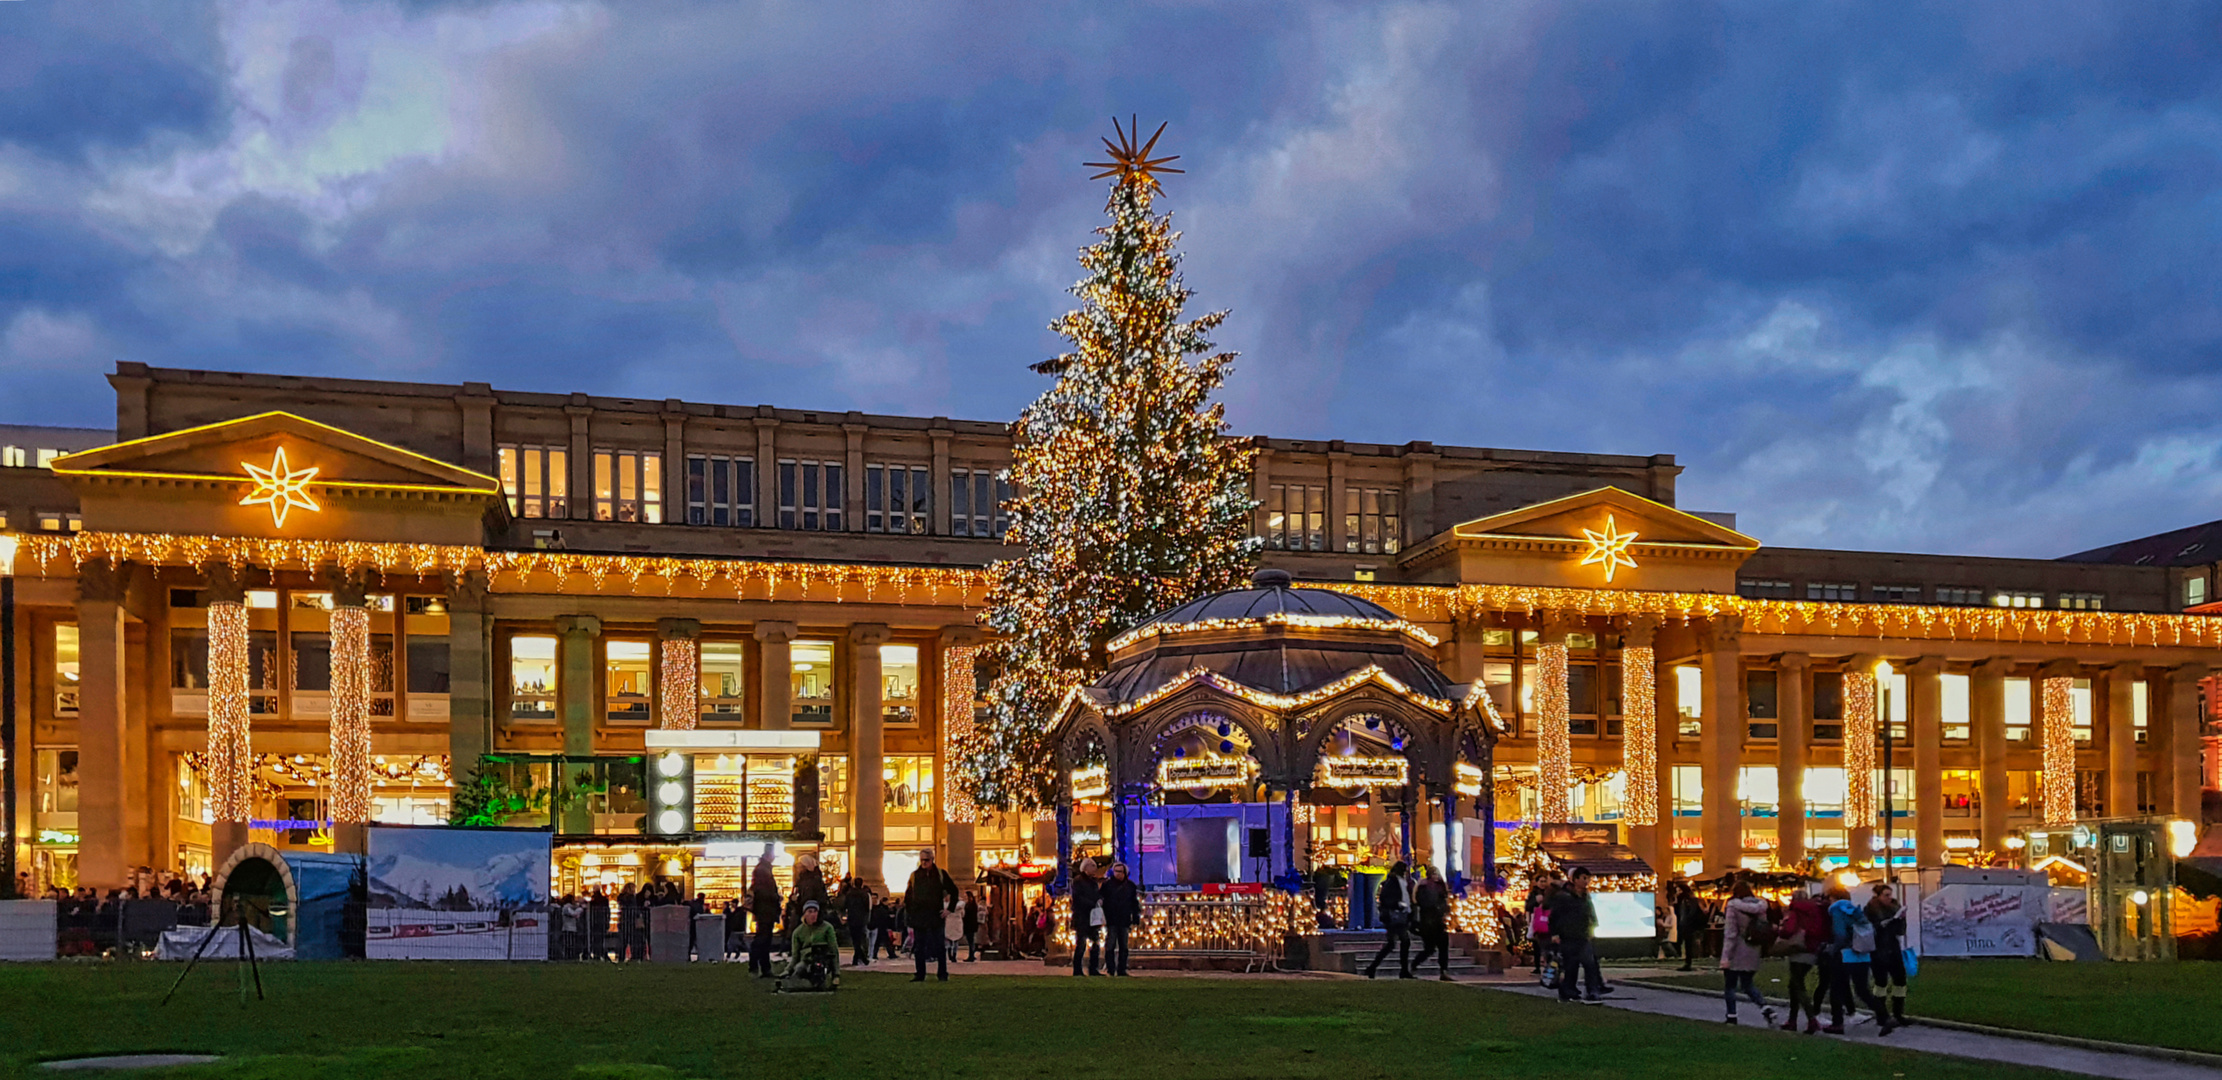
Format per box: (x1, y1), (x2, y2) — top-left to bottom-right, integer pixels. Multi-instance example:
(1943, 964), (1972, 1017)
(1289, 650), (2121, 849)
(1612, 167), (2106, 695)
(955, 122), (1258, 809)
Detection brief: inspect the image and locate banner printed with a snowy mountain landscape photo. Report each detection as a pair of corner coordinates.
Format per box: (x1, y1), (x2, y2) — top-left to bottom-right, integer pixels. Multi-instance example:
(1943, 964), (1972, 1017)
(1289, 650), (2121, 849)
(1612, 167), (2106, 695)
(364, 824), (553, 960)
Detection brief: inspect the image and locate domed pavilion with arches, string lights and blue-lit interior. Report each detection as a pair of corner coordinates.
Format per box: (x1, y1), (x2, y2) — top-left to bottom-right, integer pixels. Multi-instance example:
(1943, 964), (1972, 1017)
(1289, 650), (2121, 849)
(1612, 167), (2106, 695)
(1051, 571), (1495, 953)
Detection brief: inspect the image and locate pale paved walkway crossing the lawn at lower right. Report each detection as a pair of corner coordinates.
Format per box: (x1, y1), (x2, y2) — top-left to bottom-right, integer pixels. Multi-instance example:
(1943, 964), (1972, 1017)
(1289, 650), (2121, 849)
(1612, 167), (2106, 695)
(1487, 969), (2222, 1080)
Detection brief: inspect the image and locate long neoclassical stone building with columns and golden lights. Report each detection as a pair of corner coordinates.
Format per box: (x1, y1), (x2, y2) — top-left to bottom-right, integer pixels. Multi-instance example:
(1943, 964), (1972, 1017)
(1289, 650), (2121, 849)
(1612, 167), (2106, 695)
(0, 364), (2222, 893)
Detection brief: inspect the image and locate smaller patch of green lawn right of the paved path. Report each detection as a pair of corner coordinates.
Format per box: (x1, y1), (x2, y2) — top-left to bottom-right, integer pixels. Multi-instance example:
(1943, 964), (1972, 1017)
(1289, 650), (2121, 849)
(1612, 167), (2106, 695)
(1644, 960), (2222, 1053)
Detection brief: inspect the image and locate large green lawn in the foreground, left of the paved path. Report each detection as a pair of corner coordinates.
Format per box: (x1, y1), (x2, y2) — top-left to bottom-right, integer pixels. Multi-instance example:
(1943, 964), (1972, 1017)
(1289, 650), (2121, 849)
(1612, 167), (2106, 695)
(0, 962), (2097, 1080)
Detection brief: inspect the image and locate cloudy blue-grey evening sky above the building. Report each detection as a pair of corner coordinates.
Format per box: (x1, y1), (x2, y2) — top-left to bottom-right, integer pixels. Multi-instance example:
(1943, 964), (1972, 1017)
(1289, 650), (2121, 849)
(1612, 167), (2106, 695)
(0, 0), (2222, 556)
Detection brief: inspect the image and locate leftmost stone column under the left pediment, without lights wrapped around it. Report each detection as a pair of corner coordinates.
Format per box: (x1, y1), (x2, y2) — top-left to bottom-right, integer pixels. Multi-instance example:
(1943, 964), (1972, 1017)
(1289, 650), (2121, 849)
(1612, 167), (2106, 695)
(78, 562), (129, 891)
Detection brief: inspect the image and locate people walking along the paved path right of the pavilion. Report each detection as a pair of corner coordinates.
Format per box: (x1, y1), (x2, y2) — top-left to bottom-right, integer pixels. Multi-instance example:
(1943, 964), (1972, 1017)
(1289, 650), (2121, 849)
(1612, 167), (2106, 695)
(1528, 867), (1906, 1036)
